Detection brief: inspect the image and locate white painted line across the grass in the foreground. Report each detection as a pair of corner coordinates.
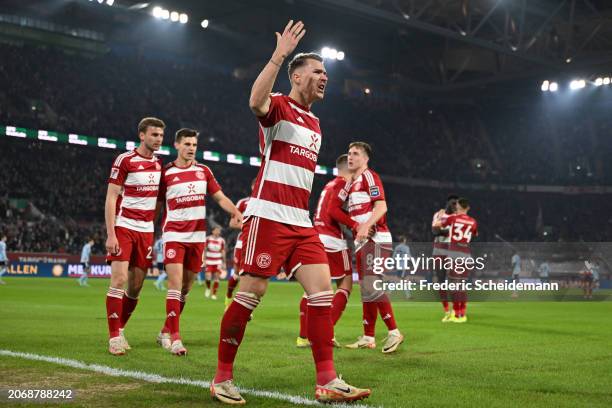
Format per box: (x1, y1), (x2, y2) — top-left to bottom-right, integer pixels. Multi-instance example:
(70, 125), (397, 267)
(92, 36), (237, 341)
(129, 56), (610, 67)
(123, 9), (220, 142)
(0, 350), (371, 408)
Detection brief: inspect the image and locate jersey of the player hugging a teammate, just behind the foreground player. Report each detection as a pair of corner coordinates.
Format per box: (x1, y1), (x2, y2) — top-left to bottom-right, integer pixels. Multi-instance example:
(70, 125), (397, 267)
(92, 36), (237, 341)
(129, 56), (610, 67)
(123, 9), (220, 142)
(314, 177), (351, 252)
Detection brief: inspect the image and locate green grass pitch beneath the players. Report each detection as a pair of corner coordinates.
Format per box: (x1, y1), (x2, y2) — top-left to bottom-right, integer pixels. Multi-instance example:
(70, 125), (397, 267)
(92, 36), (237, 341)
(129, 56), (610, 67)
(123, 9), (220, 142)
(0, 278), (612, 407)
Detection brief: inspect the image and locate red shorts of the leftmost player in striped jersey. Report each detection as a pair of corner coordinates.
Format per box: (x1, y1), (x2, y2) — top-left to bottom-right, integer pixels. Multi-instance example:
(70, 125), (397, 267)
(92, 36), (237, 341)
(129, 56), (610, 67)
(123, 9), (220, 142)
(106, 227), (154, 270)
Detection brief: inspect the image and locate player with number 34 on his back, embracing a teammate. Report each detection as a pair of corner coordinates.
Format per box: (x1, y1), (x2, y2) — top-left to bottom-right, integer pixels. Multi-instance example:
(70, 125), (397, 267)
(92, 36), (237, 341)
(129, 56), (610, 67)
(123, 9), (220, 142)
(436, 198), (478, 323)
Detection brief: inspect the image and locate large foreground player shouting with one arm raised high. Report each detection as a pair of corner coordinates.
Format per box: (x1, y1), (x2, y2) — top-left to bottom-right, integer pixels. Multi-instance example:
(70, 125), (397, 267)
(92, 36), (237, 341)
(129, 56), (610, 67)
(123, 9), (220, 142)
(210, 21), (370, 404)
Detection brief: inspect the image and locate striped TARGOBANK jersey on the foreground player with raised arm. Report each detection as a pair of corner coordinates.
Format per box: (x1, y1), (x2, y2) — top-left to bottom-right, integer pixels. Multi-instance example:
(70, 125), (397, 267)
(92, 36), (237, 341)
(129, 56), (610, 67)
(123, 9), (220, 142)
(244, 94), (321, 227)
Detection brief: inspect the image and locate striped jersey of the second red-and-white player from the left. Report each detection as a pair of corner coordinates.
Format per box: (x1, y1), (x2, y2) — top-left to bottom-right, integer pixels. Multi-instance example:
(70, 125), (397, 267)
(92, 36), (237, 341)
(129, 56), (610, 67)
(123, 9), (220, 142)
(159, 161), (221, 243)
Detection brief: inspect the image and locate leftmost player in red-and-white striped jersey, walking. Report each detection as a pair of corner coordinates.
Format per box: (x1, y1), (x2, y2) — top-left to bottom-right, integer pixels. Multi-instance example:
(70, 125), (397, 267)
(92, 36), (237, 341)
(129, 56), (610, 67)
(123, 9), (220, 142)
(104, 118), (166, 355)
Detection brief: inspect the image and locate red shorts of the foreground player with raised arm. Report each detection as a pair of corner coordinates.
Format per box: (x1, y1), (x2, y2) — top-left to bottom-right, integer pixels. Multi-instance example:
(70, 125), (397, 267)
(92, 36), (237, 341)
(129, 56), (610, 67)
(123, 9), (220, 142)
(239, 217), (328, 278)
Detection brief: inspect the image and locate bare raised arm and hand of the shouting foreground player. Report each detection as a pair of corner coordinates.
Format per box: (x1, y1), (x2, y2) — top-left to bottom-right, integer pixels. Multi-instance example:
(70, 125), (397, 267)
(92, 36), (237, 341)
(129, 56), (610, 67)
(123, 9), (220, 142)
(249, 20), (306, 116)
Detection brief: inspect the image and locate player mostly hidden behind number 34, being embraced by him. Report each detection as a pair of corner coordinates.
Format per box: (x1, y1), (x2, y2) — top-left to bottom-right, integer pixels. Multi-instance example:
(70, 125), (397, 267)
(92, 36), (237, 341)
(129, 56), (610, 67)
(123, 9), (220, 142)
(431, 194), (459, 323)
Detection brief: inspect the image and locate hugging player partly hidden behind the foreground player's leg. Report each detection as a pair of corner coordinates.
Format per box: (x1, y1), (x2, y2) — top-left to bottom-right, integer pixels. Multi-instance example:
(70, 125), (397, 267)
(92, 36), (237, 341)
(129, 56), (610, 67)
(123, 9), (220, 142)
(296, 154), (358, 347)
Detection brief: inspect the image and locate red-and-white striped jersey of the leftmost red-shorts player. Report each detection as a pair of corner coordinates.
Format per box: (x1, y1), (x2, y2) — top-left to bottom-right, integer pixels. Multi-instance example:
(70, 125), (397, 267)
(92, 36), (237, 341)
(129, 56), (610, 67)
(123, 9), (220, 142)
(108, 150), (162, 232)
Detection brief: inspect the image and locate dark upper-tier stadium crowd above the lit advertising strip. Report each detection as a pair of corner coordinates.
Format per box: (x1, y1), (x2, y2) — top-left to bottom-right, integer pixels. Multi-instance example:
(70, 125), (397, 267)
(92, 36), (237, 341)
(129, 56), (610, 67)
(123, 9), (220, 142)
(0, 41), (612, 188)
